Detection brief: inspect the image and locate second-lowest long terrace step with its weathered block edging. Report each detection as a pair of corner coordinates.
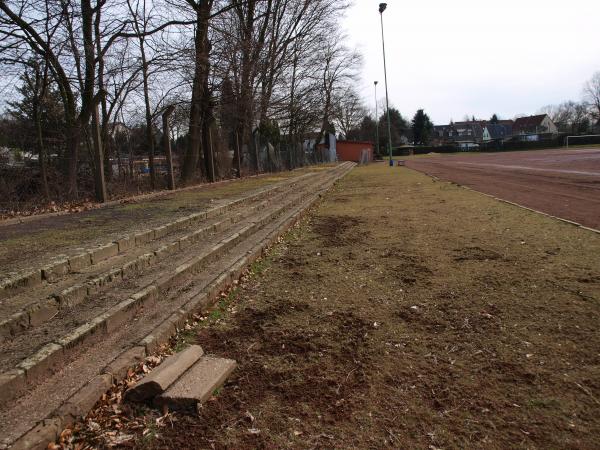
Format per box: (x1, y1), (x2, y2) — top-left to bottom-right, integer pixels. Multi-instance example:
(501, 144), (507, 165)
(0, 171), (337, 400)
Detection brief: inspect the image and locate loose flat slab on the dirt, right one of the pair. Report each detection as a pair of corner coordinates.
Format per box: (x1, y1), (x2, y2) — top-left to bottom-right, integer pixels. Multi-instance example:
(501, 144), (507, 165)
(154, 356), (236, 410)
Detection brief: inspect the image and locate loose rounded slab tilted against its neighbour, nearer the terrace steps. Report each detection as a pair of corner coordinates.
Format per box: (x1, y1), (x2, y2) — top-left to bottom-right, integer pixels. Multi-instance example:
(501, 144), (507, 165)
(125, 345), (204, 402)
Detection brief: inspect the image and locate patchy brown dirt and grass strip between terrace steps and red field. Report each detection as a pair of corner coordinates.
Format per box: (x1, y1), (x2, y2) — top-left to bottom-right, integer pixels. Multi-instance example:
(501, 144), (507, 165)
(76, 164), (600, 449)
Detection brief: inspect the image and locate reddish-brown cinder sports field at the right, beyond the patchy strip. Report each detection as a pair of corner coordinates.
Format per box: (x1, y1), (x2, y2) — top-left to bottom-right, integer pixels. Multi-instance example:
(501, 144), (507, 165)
(407, 148), (600, 229)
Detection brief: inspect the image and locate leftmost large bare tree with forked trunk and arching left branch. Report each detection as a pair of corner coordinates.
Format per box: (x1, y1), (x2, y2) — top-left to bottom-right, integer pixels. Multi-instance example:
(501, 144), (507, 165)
(0, 0), (116, 196)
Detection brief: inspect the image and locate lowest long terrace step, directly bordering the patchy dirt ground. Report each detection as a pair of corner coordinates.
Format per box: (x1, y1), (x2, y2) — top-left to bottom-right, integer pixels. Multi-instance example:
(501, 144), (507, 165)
(0, 165), (352, 448)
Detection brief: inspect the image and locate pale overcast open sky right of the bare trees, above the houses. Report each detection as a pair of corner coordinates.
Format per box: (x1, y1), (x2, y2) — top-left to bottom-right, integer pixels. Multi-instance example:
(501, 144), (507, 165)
(345, 0), (600, 124)
